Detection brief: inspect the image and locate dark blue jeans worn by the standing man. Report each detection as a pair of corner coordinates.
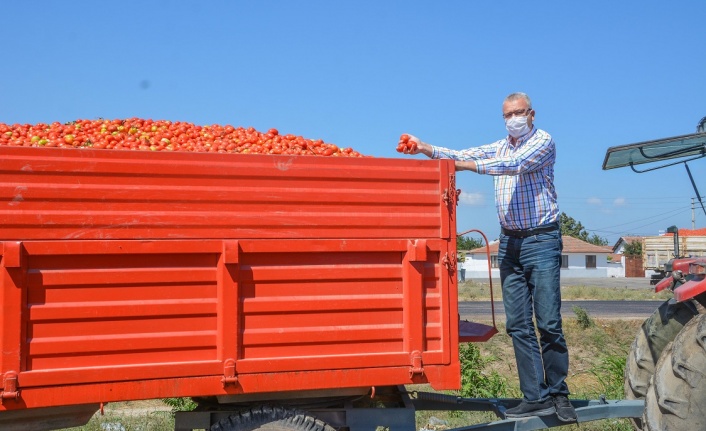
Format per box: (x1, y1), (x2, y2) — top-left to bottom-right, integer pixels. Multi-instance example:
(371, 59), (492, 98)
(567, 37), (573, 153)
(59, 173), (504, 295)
(498, 229), (569, 402)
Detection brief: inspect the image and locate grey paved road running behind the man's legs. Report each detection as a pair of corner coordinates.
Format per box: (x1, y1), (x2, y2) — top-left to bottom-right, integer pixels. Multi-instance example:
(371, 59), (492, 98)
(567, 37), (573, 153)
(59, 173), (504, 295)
(458, 300), (664, 321)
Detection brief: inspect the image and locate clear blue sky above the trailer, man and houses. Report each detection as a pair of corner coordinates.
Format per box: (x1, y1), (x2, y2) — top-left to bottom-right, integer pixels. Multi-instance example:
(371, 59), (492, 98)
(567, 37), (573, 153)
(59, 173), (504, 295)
(0, 0), (706, 245)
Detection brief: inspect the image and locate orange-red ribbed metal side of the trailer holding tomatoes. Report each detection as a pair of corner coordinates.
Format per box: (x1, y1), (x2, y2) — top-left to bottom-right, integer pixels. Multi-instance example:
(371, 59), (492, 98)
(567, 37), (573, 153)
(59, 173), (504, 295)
(0, 147), (460, 414)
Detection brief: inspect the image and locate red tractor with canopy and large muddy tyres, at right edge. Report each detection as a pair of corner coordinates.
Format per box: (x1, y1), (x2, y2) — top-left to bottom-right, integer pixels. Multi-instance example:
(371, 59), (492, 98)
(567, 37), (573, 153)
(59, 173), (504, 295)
(603, 117), (706, 431)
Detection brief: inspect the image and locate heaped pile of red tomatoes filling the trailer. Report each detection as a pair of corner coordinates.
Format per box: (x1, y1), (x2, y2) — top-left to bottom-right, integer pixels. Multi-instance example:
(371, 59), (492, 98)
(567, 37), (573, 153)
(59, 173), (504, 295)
(0, 118), (362, 157)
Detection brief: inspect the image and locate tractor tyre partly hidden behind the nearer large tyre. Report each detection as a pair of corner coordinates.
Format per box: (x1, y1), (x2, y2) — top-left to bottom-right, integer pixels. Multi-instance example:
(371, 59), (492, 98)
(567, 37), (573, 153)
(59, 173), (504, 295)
(624, 300), (696, 431)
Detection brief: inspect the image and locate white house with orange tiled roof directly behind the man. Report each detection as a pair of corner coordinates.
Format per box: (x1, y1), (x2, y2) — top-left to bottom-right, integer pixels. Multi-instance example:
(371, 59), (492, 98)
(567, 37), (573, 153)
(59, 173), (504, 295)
(463, 236), (618, 278)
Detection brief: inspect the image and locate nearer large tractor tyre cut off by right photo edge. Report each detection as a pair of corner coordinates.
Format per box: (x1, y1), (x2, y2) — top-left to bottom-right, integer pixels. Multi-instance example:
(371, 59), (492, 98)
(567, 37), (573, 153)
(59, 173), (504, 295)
(643, 315), (706, 431)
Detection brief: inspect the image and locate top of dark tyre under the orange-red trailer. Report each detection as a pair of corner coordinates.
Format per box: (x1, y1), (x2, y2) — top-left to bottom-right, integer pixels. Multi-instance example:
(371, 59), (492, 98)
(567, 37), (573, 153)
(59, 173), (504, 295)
(211, 406), (335, 431)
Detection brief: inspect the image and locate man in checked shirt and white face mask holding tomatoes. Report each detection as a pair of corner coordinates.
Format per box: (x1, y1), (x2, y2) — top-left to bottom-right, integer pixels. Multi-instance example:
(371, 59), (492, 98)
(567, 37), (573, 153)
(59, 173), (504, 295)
(404, 93), (577, 422)
